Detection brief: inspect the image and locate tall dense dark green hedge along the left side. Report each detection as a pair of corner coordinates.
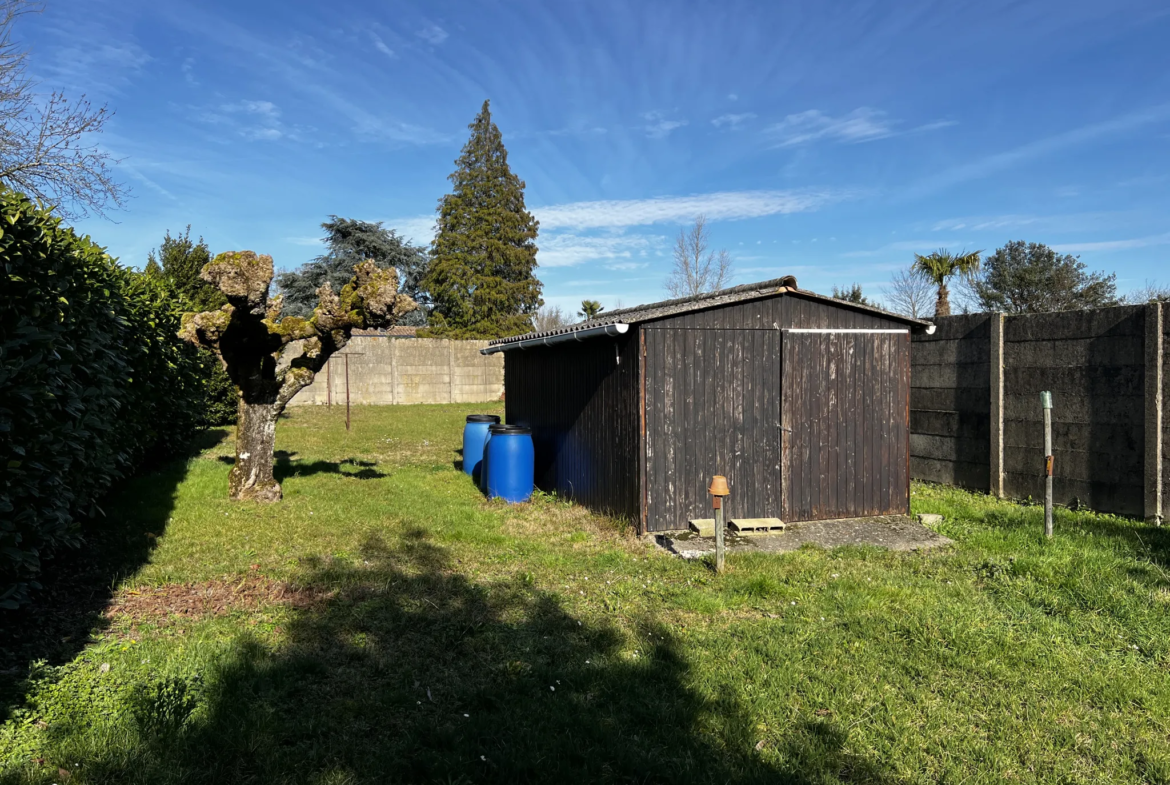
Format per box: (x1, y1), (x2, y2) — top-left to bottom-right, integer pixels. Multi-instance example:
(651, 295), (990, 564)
(0, 192), (207, 608)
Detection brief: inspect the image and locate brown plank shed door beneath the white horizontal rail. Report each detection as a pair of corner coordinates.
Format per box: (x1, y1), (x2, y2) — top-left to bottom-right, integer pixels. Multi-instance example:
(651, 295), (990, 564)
(782, 330), (910, 521)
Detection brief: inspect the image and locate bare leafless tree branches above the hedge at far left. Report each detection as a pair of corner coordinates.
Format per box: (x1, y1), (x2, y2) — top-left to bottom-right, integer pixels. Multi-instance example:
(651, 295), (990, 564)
(0, 0), (128, 218)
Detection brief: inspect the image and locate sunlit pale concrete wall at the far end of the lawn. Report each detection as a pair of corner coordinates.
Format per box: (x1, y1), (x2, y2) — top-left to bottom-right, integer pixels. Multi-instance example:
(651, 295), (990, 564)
(290, 336), (504, 406)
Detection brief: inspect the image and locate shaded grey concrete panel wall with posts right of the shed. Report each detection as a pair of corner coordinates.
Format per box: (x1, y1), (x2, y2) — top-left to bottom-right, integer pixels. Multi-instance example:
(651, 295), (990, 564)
(910, 305), (1170, 518)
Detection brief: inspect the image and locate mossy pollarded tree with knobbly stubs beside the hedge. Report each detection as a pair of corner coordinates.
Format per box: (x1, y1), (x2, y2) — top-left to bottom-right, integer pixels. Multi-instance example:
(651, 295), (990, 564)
(179, 250), (418, 502)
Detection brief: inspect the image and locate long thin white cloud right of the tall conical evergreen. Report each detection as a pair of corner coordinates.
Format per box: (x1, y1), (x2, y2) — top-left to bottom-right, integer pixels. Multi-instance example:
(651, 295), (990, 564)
(532, 191), (852, 229)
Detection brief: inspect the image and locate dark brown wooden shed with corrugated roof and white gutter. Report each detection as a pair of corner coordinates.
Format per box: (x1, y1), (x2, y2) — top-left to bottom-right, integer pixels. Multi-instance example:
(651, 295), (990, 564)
(483, 276), (932, 533)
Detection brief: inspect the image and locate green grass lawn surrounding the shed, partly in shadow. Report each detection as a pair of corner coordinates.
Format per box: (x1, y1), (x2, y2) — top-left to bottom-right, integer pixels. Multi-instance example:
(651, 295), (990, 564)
(0, 405), (1170, 785)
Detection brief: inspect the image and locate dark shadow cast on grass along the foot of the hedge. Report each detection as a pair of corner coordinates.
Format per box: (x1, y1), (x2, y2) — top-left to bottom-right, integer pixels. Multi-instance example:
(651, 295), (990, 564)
(0, 428), (228, 721)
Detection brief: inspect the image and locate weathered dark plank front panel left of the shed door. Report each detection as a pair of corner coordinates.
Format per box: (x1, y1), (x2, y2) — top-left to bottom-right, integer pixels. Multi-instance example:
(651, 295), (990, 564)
(645, 328), (780, 531)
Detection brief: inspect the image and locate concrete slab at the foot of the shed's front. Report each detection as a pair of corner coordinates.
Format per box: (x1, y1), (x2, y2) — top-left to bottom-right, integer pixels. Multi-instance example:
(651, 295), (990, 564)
(655, 515), (952, 559)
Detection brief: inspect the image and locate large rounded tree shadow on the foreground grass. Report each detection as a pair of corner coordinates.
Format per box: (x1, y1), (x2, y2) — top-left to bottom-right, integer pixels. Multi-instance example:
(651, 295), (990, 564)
(45, 530), (890, 785)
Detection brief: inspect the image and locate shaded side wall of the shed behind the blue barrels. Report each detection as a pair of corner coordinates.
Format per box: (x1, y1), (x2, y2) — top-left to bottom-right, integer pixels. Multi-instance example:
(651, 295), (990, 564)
(504, 331), (641, 519)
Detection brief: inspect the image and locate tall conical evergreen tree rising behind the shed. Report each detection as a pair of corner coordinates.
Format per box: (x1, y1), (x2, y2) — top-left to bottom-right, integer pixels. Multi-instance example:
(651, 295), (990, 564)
(420, 101), (544, 338)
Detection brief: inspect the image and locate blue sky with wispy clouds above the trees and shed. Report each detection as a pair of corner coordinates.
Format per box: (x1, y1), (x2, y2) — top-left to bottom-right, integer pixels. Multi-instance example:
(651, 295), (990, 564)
(20, 0), (1170, 310)
